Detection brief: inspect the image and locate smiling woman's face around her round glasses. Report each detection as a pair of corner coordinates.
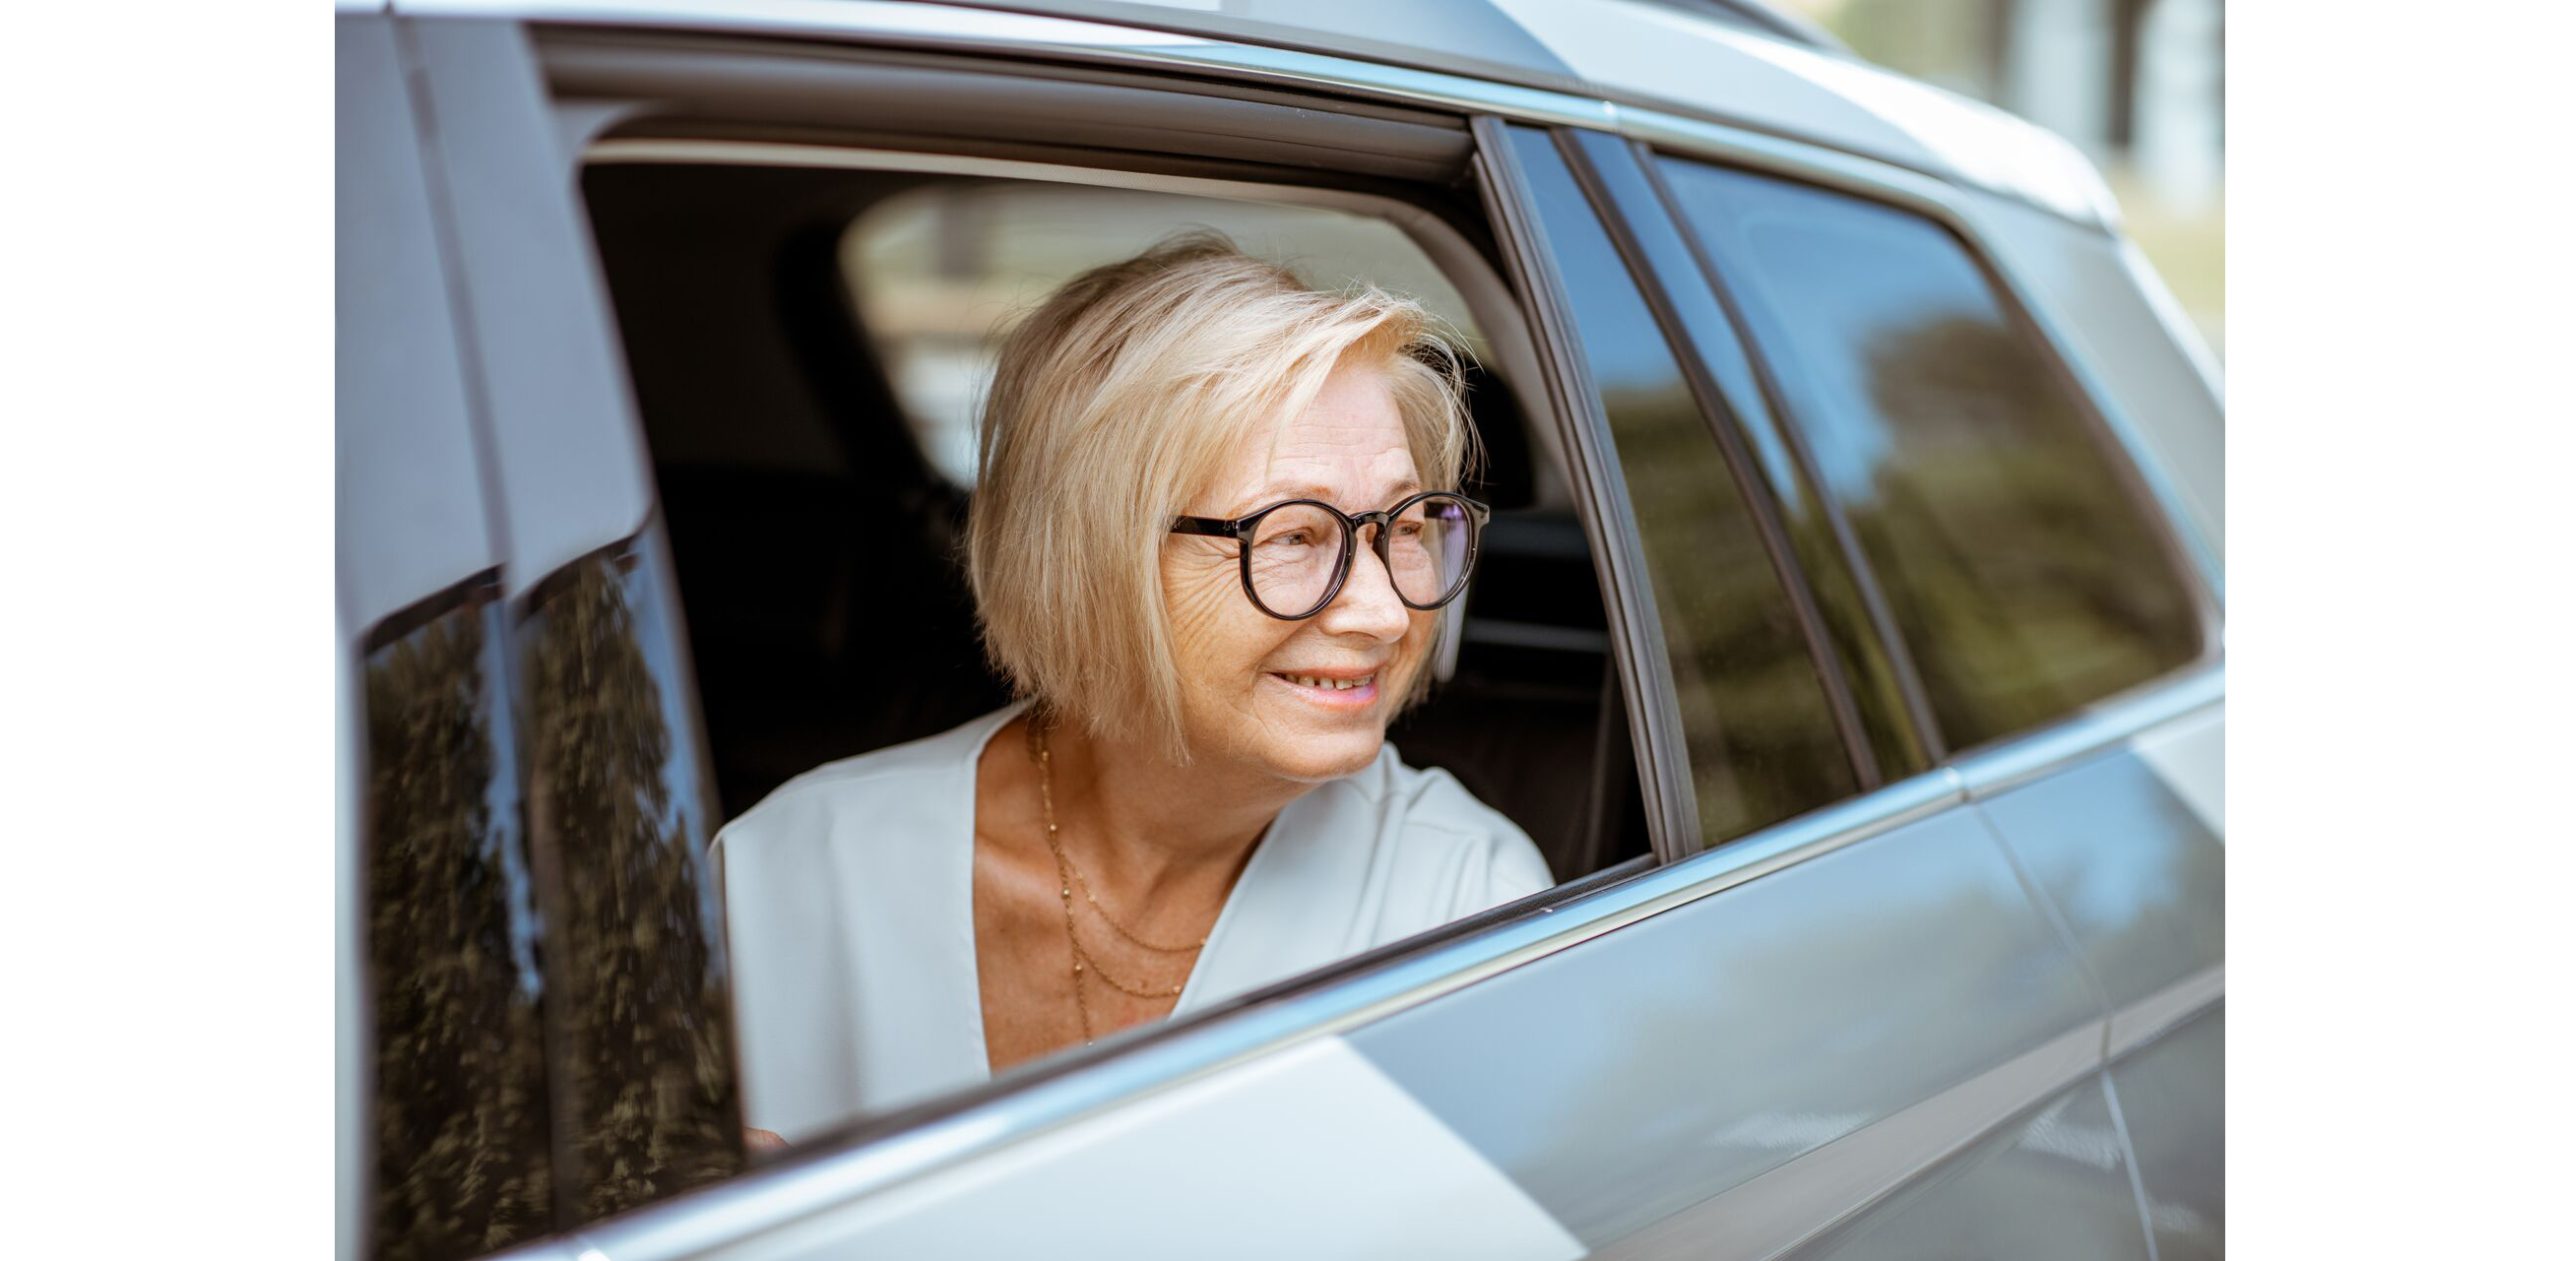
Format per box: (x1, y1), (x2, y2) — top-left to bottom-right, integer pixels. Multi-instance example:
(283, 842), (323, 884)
(1162, 366), (1439, 783)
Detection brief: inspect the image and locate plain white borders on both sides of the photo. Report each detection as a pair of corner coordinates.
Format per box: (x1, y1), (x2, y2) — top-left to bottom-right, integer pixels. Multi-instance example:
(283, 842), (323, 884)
(0, 0), (2560, 1256)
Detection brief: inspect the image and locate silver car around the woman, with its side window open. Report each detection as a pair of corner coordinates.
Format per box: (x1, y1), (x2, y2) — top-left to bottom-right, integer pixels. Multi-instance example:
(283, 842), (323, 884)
(338, 0), (2222, 1261)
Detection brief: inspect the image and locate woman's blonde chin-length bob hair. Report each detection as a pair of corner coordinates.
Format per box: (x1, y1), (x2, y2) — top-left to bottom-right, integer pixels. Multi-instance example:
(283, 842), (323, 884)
(968, 233), (1477, 762)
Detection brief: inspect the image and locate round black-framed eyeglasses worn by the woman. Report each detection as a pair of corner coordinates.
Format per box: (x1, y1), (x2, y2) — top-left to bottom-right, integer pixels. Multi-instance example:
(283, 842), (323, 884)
(1172, 491), (1492, 622)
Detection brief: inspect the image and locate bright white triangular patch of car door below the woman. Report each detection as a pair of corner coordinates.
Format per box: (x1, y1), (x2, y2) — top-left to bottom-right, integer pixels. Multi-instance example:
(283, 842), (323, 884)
(650, 1038), (1585, 1261)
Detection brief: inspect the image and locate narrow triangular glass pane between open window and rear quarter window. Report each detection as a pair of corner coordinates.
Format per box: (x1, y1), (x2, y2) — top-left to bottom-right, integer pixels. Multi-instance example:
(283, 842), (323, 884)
(1513, 128), (1856, 844)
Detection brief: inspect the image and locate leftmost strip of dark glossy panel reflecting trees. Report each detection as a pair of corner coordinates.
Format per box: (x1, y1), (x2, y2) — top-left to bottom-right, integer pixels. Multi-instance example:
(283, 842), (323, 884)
(364, 583), (550, 1261)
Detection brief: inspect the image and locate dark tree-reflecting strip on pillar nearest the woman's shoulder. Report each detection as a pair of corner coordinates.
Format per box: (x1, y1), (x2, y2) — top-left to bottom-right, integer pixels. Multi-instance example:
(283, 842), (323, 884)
(525, 547), (742, 1220)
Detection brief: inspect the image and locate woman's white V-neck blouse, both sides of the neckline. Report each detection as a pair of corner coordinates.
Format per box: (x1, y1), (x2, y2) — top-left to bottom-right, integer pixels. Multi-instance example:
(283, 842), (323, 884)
(712, 706), (1554, 1141)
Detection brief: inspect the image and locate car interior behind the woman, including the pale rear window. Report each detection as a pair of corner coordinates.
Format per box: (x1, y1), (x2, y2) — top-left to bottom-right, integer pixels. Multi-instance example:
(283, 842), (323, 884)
(581, 141), (1651, 882)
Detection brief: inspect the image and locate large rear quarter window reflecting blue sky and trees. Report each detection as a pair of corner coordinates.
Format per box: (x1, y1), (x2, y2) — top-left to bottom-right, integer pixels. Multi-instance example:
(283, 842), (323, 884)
(1664, 161), (2202, 749)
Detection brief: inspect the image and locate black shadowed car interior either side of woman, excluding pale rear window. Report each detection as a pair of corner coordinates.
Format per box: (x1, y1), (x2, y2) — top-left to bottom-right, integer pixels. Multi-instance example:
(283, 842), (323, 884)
(584, 161), (1649, 880)
